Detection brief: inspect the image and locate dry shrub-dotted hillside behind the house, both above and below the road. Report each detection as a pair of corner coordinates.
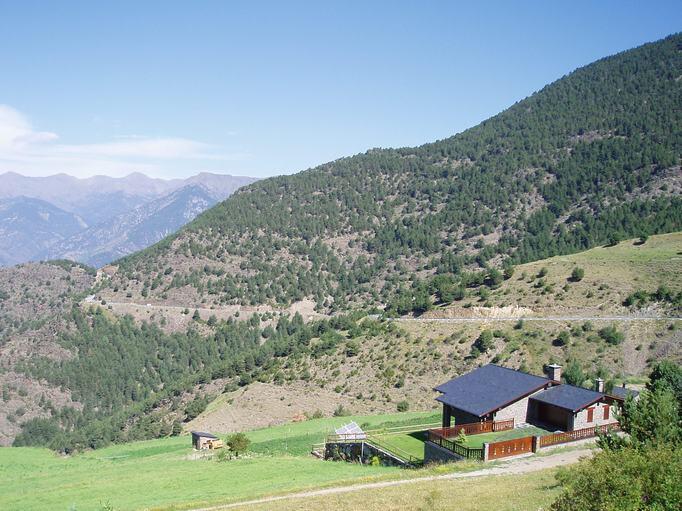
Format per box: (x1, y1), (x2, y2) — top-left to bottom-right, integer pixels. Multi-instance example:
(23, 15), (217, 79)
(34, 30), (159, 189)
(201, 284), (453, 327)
(183, 233), (682, 431)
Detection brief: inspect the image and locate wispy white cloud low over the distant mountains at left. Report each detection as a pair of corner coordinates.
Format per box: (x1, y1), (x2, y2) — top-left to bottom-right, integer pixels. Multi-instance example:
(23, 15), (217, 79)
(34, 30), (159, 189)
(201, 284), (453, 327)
(0, 105), (248, 176)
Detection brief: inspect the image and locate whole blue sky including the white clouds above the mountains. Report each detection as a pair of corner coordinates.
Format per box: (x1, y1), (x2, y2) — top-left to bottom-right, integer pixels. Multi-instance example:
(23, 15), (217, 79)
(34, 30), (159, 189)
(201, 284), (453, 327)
(0, 0), (682, 178)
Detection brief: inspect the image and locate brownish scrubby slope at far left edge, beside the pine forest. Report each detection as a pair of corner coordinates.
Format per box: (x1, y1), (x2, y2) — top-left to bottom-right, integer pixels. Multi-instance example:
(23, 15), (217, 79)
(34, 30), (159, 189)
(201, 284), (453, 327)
(0, 261), (95, 446)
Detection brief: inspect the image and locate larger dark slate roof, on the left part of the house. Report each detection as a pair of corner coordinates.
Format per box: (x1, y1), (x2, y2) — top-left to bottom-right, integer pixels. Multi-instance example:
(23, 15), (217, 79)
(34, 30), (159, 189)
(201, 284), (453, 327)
(434, 364), (552, 417)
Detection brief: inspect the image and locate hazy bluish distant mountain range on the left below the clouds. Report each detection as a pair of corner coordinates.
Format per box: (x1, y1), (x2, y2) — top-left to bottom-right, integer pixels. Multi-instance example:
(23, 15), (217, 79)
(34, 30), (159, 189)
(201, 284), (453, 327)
(0, 172), (256, 266)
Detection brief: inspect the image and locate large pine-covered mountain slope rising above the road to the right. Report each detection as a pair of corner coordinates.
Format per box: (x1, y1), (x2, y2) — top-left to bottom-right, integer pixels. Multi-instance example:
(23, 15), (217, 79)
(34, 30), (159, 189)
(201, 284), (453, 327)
(109, 34), (682, 311)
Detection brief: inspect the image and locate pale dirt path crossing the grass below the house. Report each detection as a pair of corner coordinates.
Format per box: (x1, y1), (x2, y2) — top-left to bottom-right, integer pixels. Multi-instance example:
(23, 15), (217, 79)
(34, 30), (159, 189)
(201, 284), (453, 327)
(191, 449), (592, 511)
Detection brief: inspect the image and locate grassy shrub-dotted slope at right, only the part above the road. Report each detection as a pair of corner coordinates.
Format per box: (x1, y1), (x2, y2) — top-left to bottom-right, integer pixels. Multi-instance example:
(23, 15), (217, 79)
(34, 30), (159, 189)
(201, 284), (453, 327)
(426, 232), (682, 317)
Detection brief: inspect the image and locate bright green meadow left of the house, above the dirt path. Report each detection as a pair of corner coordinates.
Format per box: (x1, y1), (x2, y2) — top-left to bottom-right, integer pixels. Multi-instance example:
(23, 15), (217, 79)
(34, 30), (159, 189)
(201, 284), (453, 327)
(0, 412), (440, 511)
